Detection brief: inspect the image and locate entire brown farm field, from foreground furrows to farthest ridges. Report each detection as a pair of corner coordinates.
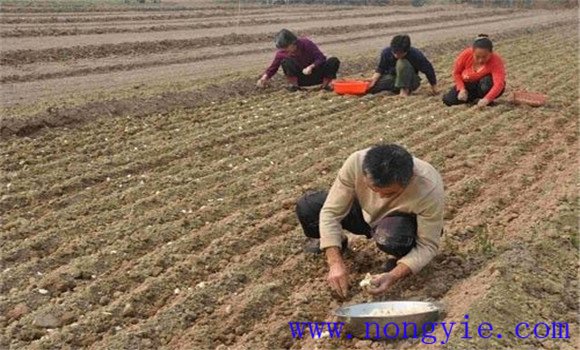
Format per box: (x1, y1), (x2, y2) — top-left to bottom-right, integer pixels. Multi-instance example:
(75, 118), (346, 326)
(0, 2), (580, 349)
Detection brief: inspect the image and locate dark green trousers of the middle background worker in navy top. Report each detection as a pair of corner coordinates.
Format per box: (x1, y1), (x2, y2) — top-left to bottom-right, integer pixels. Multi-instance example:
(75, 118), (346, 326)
(369, 58), (421, 94)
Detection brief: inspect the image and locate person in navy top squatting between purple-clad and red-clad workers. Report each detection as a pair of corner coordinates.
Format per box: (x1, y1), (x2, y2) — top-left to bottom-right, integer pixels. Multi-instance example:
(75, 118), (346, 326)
(368, 35), (438, 96)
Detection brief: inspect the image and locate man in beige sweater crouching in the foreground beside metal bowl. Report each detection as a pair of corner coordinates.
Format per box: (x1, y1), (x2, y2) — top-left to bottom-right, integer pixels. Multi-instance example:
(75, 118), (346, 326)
(296, 144), (444, 297)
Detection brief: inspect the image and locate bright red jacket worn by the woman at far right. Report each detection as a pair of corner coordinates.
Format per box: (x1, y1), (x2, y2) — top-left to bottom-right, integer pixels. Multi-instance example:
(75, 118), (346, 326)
(453, 47), (506, 101)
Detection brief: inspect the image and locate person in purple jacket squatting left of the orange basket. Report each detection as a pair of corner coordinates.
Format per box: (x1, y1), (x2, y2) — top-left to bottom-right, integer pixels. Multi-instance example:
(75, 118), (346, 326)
(257, 29), (340, 92)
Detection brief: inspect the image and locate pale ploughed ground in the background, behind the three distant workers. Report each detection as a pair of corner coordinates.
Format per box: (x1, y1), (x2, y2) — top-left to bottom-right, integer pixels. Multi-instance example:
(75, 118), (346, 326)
(0, 0), (577, 115)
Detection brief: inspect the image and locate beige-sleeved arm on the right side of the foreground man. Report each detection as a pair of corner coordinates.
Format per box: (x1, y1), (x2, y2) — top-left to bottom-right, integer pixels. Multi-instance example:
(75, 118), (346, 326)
(397, 183), (445, 274)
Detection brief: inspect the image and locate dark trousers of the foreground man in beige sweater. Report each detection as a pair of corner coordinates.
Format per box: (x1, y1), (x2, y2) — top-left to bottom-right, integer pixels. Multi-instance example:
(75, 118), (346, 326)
(296, 191), (417, 258)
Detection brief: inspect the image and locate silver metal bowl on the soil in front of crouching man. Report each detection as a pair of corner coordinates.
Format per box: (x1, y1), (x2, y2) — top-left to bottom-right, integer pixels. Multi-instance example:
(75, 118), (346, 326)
(334, 301), (442, 340)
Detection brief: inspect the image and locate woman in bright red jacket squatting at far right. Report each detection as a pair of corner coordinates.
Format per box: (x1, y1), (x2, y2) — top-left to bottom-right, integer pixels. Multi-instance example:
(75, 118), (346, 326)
(443, 34), (506, 107)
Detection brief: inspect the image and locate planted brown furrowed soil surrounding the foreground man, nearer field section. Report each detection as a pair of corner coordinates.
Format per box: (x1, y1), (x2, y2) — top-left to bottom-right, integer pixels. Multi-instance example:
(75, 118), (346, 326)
(0, 22), (579, 349)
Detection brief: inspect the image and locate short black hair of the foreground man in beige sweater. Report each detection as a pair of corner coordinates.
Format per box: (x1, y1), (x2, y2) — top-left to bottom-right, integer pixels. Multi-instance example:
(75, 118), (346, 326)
(363, 143), (414, 187)
